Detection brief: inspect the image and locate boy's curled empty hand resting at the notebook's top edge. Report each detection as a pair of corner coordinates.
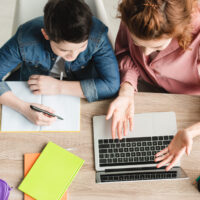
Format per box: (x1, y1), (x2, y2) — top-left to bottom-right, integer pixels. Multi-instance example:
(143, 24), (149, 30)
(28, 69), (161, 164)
(28, 75), (60, 95)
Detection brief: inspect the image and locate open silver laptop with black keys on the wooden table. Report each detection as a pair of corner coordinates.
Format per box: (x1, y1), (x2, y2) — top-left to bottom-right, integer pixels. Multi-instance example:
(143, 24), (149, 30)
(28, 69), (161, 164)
(93, 112), (188, 183)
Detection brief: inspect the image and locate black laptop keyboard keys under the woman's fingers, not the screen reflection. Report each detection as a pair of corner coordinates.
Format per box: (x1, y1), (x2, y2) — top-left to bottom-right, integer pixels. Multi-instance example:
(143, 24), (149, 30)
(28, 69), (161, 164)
(98, 135), (173, 167)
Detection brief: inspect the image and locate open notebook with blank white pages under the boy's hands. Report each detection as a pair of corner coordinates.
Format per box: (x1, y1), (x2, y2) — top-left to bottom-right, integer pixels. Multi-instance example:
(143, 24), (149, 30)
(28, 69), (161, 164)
(1, 81), (80, 132)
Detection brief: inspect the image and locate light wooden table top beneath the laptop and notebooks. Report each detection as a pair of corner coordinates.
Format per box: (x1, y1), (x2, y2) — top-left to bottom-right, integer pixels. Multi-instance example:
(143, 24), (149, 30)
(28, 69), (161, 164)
(0, 93), (200, 200)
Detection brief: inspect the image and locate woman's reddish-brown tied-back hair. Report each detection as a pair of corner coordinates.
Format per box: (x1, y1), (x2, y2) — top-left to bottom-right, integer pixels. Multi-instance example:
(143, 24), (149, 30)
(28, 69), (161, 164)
(118, 0), (197, 50)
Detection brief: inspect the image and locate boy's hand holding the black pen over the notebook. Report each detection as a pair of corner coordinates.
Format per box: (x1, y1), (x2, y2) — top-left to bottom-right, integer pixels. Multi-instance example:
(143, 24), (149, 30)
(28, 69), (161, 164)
(22, 103), (56, 126)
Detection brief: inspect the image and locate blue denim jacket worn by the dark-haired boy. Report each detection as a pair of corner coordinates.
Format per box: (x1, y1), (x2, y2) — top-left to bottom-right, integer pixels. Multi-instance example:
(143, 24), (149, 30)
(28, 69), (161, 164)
(0, 17), (120, 102)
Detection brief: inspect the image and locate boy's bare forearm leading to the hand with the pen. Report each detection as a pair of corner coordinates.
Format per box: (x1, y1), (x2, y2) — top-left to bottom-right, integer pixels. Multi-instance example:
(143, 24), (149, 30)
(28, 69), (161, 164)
(0, 91), (27, 113)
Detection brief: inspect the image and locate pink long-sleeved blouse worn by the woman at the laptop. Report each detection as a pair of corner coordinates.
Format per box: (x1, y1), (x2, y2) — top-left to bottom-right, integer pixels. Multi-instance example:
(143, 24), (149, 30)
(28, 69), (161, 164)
(115, 8), (200, 95)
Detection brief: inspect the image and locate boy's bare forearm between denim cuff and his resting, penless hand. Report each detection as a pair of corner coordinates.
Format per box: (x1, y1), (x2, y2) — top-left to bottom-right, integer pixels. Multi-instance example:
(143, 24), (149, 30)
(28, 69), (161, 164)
(59, 81), (85, 98)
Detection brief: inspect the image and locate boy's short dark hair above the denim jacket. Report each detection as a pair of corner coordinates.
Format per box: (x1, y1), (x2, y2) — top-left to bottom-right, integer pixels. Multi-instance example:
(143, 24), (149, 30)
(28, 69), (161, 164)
(44, 0), (92, 43)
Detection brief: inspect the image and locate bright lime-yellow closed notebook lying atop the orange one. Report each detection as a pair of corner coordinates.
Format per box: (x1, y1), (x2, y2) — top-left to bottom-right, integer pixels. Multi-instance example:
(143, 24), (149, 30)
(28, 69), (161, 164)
(18, 142), (84, 200)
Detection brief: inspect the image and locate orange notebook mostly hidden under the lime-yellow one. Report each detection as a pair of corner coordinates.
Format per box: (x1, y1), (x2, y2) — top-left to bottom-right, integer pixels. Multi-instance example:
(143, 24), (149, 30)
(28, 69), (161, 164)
(24, 153), (67, 200)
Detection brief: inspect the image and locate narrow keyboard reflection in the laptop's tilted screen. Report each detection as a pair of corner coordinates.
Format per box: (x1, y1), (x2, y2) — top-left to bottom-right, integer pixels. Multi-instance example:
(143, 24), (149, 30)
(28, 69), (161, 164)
(100, 171), (177, 182)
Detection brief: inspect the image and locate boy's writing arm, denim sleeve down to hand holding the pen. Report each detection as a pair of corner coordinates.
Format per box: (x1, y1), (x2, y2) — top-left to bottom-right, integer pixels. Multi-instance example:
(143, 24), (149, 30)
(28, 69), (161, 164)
(0, 28), (55, 125)
